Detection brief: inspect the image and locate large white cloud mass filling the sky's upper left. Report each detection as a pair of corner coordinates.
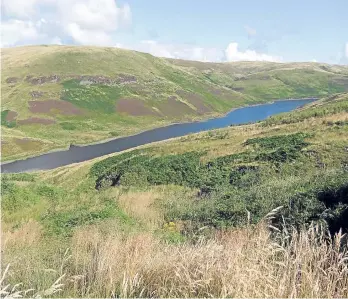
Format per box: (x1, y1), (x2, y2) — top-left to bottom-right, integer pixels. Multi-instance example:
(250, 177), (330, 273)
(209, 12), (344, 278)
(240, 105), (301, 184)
(1, 0), (132, 46)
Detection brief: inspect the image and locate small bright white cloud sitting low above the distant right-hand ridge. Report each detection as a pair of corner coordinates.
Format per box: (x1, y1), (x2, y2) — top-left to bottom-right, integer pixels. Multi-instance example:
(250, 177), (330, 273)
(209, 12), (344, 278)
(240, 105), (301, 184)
(225, 42), (282, 62)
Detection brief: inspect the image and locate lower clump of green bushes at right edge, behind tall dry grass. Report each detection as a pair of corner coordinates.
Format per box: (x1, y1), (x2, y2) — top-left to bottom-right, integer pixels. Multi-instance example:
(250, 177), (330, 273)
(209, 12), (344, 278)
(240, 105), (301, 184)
(165, 170), (348, 233)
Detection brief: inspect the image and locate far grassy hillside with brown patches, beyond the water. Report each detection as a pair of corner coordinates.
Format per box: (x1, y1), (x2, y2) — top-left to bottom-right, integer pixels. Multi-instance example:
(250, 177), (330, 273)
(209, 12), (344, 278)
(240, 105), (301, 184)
(1, 46), (348, 160)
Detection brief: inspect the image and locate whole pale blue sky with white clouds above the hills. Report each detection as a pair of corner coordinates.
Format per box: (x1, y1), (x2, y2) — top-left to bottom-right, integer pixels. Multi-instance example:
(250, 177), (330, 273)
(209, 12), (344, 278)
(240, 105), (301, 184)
(1, 0), (348, 65)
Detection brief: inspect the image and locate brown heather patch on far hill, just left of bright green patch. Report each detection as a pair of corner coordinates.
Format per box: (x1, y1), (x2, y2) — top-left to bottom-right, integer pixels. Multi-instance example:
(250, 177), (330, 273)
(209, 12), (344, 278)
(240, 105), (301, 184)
(29, 100), (82, 115)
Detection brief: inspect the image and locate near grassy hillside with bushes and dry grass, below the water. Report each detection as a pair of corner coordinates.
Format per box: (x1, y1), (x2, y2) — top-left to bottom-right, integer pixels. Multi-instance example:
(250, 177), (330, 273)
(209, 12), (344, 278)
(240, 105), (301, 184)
(2, 93), (348, 298)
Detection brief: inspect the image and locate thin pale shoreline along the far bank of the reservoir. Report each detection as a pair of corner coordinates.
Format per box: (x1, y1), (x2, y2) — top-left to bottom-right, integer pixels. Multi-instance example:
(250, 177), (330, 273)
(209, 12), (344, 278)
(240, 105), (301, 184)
(0, 97), (319, 167)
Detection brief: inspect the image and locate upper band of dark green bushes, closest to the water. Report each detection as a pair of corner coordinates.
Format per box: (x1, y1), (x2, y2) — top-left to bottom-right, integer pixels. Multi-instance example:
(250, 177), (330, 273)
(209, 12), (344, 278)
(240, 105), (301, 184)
(90, 133), (310, 193)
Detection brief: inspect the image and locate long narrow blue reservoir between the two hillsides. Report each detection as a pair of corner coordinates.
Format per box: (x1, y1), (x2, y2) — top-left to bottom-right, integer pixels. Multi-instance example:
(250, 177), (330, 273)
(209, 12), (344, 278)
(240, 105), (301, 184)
(1, 99), (315, 173)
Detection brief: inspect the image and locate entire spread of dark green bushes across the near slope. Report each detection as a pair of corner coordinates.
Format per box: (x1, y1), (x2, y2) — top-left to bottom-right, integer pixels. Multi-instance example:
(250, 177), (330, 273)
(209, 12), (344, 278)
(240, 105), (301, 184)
(91, 132), (348, 234)
